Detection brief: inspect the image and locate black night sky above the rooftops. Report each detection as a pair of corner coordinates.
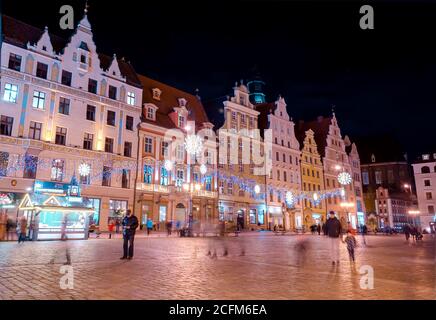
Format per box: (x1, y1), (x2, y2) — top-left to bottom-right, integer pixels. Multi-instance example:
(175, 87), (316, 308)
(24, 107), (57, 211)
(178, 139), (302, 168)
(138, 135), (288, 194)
(2, 0), (436, 158)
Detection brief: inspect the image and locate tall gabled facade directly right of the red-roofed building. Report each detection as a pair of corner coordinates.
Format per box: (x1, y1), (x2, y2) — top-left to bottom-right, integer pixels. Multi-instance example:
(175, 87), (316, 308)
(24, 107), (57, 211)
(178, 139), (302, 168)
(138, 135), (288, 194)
(218, 83), (268, 229)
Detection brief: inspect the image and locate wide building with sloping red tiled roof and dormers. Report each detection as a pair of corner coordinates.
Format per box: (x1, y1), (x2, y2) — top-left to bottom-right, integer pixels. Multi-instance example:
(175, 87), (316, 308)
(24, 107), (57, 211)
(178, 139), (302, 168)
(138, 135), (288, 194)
(136, 76), (218, 230)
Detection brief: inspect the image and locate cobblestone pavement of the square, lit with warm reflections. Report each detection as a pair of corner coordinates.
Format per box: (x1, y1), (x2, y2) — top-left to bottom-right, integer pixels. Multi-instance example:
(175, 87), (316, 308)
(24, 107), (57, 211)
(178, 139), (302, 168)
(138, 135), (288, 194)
(0, 234), (436, 300)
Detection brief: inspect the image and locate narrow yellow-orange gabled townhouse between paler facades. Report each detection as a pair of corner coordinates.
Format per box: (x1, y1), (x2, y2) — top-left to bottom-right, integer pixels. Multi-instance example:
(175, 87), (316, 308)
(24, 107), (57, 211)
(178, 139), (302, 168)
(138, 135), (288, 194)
(299, 129), (326, 230)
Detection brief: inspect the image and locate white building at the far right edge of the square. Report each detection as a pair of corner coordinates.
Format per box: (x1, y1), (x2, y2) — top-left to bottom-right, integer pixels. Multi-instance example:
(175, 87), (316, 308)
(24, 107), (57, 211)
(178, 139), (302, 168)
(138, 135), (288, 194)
(412, 153), (436, 232)
